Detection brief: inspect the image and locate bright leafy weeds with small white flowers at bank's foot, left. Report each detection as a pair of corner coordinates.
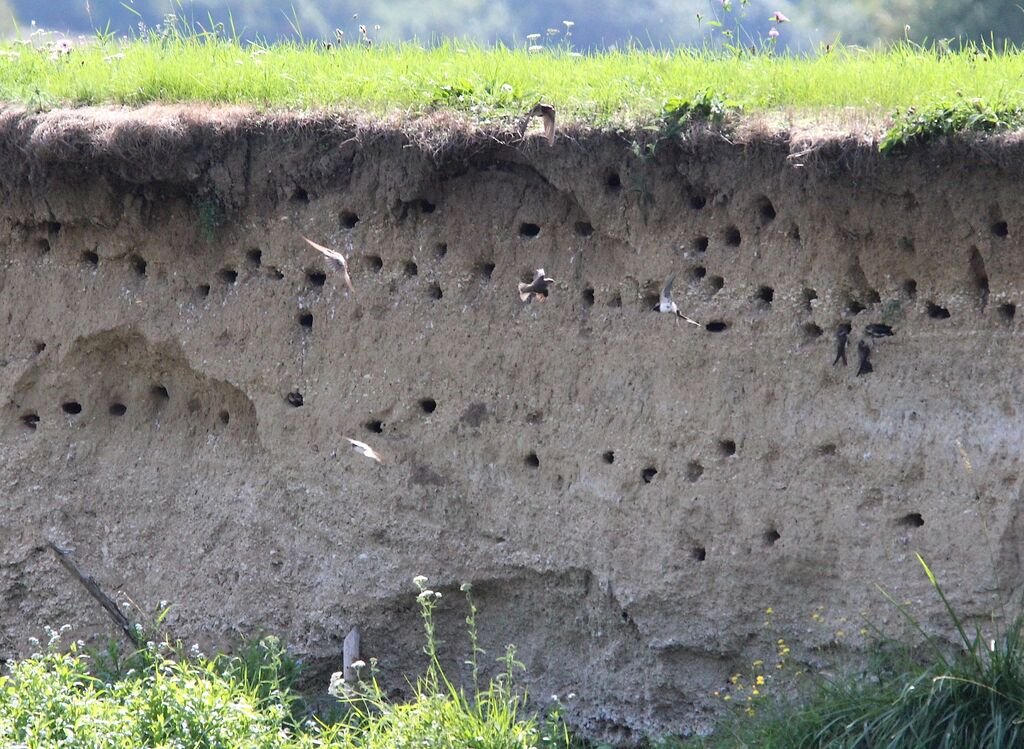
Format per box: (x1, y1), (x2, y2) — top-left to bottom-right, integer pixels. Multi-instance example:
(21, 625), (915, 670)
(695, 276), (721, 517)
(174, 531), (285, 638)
(0, 578), (571, 749)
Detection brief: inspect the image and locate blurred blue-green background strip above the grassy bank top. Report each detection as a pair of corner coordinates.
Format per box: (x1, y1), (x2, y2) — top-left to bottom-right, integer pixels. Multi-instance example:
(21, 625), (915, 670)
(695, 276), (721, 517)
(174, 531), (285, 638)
(14, 0), (1024, 52)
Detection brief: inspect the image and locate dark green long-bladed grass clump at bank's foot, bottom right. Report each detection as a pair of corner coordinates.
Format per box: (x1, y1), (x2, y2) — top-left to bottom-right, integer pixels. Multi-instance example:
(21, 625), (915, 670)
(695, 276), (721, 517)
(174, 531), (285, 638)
(658, 556), (1024, 749)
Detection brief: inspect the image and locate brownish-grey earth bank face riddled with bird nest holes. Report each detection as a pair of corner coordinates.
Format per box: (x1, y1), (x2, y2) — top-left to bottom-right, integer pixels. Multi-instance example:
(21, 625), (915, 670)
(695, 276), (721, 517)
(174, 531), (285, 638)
(0, 108), (1024, 741)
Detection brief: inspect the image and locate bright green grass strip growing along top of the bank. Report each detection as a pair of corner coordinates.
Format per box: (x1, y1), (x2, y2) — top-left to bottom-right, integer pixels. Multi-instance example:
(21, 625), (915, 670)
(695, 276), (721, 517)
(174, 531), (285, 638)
(0, 28), (1024, 125)
